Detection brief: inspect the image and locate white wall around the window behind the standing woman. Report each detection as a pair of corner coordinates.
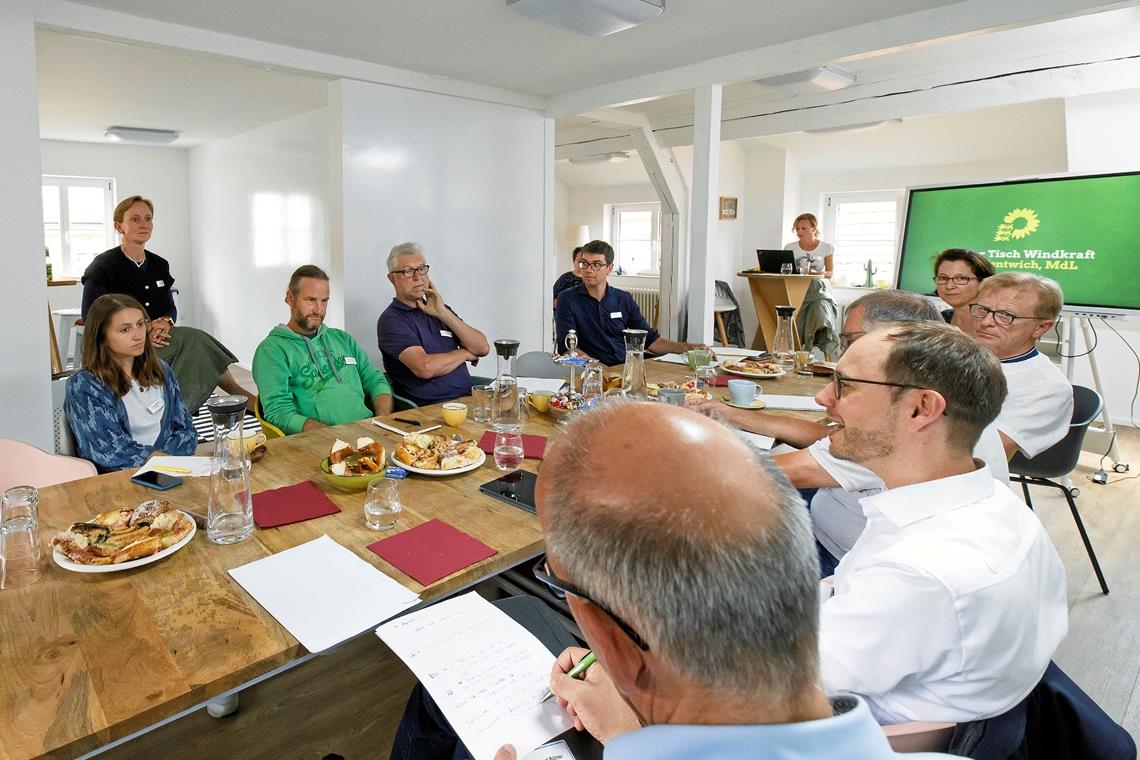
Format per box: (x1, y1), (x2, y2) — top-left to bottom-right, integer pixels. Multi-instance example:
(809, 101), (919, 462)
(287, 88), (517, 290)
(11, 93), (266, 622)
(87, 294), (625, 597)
(40, 140), (195, 316)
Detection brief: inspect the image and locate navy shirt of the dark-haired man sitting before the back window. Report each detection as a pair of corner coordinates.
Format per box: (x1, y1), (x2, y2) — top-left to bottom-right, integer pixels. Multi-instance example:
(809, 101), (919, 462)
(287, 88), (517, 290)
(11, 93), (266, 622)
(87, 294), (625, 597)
(554, 284), (661, 366)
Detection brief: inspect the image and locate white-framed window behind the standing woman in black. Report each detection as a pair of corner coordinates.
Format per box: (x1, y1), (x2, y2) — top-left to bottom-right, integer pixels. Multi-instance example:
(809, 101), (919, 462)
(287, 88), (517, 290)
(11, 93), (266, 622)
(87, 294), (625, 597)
(42, 174), (116, 279)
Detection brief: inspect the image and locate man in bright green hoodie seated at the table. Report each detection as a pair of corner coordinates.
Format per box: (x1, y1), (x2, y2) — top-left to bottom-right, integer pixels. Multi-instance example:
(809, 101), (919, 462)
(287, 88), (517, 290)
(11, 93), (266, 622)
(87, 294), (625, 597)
(253, 264), (392, 435)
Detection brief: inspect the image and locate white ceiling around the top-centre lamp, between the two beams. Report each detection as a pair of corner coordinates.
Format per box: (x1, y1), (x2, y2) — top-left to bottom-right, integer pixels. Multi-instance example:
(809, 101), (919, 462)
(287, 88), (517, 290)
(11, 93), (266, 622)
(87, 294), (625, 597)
(68, 0), (958, 96)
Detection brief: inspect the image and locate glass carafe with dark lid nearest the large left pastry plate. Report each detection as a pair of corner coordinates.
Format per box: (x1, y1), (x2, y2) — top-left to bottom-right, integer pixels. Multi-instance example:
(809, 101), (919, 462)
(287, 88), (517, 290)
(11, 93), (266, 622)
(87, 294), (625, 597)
(206, 395), (253, 544)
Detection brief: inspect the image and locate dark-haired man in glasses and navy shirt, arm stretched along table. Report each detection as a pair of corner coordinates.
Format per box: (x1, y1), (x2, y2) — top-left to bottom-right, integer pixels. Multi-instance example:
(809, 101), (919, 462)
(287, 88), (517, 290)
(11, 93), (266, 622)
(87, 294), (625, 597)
(554, 240), (708, 367)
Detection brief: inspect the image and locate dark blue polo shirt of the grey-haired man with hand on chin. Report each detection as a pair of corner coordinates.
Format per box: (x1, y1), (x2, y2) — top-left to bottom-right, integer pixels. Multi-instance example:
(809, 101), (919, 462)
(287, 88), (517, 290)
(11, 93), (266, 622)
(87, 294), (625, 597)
(376, 299), (471, 406)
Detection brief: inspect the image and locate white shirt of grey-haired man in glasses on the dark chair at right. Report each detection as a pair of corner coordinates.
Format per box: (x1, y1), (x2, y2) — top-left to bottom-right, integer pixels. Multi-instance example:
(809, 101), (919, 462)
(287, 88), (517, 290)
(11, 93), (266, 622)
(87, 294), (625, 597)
(998, 349), (1073, 457)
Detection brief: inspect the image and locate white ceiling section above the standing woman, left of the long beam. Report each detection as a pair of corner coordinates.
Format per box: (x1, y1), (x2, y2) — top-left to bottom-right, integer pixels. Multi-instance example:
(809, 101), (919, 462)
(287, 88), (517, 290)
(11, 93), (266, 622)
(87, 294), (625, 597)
(35, 30), (327, 147)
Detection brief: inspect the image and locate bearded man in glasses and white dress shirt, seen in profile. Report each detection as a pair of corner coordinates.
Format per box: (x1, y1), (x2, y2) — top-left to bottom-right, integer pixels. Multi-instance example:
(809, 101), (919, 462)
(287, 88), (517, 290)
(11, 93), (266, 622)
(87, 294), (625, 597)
(816, 322), (1068, 724)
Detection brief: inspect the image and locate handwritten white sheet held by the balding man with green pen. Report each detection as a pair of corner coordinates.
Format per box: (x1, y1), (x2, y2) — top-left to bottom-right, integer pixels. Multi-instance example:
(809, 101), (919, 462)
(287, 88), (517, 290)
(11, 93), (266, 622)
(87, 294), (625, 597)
(376, 591), (572, 760)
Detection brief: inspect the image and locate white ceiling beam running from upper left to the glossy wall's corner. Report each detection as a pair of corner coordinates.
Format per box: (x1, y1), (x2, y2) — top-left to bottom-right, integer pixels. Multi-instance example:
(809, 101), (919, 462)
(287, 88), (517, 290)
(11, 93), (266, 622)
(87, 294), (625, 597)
(34, 0), (546, 111)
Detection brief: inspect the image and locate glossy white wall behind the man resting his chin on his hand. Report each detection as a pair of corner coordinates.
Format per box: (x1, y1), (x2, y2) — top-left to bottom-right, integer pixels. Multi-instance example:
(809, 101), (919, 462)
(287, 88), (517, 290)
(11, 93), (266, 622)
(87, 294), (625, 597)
(331, 80), (549, 364)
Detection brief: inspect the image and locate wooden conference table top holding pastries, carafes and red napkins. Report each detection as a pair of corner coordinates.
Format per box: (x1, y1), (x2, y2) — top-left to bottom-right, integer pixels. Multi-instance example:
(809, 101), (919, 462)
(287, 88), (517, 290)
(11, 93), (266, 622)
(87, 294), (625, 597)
(0, 361), (824, 759)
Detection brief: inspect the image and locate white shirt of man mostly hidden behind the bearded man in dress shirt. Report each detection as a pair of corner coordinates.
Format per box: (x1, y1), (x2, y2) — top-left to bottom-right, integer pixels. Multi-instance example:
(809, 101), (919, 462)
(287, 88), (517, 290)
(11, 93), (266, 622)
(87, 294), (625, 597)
(807, 423), (1009, 559)
